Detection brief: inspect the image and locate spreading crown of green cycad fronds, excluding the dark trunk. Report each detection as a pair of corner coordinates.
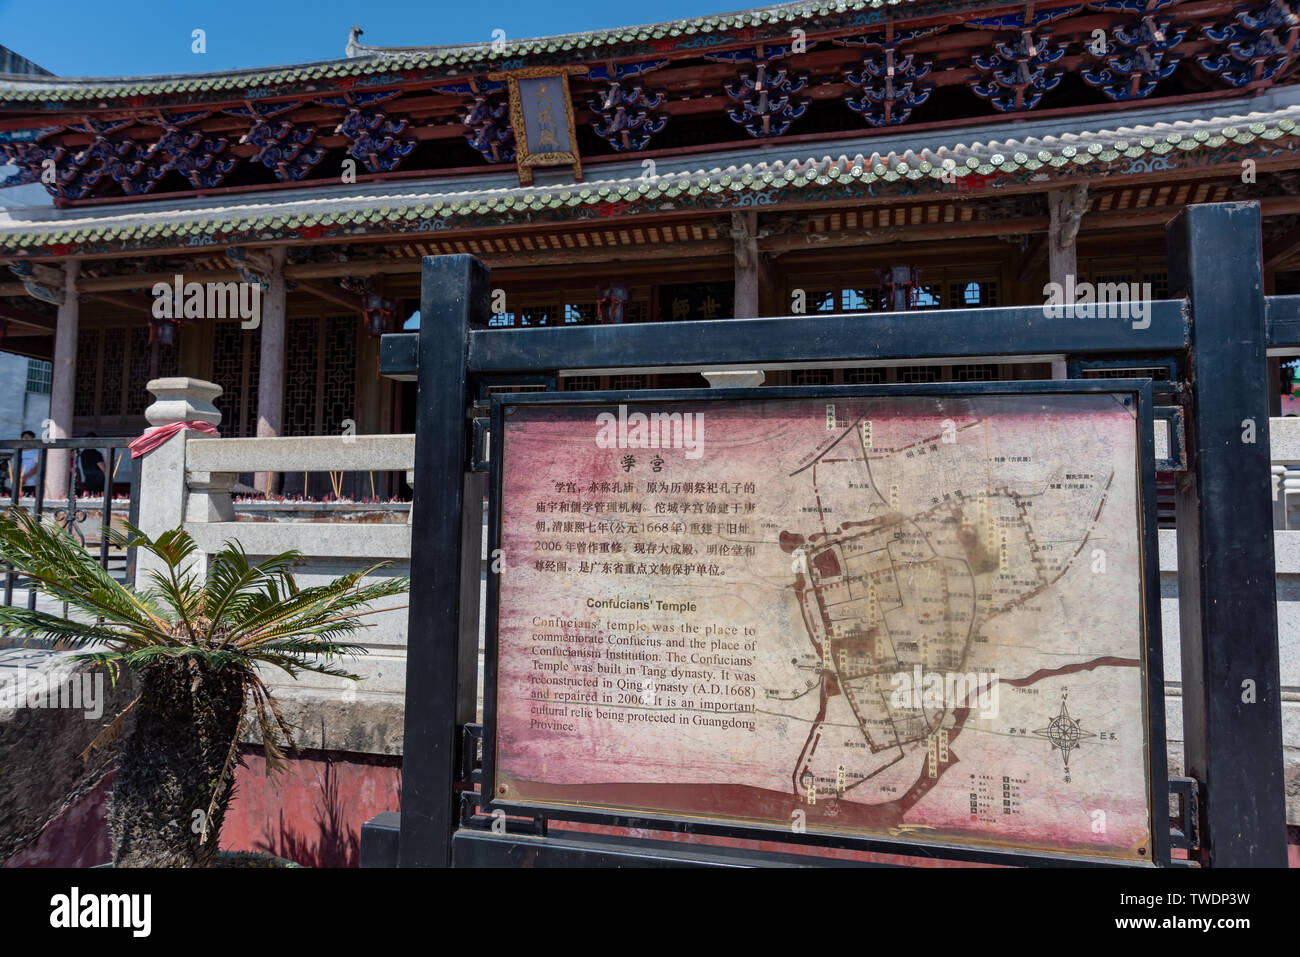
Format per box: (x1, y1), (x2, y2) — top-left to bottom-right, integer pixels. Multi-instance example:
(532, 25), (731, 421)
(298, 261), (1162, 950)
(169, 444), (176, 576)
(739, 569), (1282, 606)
(0, 508), (408, 686)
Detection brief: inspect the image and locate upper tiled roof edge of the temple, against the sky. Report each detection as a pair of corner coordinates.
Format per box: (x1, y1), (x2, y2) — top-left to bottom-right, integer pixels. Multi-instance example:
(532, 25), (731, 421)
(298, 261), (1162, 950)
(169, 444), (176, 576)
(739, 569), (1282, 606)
(0, 0), (927, 103)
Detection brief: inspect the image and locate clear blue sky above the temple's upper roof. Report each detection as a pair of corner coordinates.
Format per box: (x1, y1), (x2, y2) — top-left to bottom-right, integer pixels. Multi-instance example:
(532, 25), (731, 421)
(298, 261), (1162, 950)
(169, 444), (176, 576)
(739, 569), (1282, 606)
(0, 0), (743, 77)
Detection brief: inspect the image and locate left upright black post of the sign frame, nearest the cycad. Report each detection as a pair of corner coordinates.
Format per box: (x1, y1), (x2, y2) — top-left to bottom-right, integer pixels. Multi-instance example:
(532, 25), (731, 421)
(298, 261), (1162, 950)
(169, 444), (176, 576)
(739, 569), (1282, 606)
(398, 256), (489, 867)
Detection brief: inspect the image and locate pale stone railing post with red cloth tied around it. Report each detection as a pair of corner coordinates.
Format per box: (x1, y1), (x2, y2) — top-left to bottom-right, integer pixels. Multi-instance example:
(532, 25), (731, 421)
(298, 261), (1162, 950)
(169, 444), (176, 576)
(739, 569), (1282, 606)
(135, 376), (223, 586)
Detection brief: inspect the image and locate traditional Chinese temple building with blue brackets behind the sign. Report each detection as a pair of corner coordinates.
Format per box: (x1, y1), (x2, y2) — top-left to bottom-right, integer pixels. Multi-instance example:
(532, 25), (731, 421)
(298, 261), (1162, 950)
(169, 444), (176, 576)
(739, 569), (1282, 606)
(0, 0), (1300, 488)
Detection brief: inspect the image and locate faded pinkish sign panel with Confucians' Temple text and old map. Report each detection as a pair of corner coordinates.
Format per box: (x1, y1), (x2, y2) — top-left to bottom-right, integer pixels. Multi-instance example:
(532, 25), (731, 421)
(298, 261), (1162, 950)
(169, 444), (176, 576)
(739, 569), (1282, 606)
(494, 394), (1151, 859)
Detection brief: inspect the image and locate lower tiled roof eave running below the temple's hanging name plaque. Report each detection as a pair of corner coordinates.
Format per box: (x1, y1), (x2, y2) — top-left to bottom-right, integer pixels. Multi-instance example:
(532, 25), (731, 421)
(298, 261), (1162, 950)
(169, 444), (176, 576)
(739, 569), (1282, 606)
(0, 104), (1300, 255)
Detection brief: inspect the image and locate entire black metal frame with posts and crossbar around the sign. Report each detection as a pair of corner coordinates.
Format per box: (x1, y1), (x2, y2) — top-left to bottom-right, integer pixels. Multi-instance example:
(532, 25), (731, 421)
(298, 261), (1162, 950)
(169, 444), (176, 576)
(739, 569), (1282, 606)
(363, 203), (1300, 866)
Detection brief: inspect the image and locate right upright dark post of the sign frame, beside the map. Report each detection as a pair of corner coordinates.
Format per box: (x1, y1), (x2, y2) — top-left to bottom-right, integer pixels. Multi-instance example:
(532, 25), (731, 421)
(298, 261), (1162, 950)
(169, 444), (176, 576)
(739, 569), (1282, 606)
(1167, 203), (1287, 867)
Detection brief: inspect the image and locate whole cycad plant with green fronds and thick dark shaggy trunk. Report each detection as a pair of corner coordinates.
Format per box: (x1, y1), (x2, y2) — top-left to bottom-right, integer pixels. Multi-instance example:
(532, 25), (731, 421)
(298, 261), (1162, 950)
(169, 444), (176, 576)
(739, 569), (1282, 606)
(0, 508), (407, 867)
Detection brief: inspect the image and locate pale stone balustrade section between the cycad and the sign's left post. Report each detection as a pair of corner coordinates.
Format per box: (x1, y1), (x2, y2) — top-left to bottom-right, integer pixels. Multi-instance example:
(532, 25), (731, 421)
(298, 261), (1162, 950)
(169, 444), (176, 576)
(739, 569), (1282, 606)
(137, 378), (415, 754)
